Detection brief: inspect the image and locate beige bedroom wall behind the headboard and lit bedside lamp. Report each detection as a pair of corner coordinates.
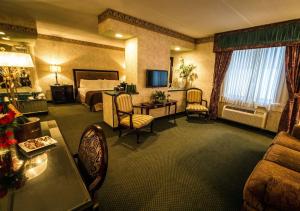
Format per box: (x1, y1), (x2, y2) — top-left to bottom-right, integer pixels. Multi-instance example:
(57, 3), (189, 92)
(34, 38), (125, 99)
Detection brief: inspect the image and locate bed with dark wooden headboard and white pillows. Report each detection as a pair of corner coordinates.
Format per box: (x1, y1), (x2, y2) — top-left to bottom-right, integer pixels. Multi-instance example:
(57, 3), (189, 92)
(73, 69), (120, 111)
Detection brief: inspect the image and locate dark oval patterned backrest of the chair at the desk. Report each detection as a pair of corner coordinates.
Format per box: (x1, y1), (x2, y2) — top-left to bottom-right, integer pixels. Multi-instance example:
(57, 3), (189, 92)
(78, 125), (108, 196)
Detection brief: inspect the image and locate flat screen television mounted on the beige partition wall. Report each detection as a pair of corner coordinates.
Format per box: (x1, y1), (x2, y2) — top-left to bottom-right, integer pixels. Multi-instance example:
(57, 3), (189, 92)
(146, 70), (168, 87)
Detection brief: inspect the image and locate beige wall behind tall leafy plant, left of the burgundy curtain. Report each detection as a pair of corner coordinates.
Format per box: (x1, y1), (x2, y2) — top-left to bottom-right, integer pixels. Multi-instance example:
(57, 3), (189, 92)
(172, 42), (215, 104)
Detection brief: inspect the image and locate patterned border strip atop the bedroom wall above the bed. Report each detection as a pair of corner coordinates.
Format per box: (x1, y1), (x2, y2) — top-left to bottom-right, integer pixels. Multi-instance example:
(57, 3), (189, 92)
(38, 34), (125, 51)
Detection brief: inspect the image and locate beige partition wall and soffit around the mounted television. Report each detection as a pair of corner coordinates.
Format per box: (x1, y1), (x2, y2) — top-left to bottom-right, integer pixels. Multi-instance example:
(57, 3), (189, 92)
(99, 19), (195, 102)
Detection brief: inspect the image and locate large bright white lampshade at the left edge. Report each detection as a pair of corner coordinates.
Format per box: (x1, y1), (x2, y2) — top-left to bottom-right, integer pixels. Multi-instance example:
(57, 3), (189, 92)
(0, 51), (34, 67)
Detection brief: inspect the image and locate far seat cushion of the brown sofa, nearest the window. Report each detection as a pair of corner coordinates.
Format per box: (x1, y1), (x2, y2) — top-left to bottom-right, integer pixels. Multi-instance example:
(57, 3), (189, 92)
(273, 132), (300, 152)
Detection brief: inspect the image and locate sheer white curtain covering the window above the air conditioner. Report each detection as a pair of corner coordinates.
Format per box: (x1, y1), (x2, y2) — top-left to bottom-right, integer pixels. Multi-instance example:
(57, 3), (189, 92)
(222, 47), (286, 107)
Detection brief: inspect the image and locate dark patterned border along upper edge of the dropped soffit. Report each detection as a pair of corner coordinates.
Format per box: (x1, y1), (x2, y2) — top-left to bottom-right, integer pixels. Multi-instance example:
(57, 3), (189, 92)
(98, 8), (195, 43)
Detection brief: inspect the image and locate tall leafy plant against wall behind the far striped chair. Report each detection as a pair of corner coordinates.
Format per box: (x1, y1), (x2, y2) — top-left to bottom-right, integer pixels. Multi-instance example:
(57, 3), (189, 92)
(176, 57), (198, 88)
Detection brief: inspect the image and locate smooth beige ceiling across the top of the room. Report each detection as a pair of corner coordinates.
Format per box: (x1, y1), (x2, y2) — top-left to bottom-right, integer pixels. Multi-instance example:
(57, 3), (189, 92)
(0, 0), (300, 42)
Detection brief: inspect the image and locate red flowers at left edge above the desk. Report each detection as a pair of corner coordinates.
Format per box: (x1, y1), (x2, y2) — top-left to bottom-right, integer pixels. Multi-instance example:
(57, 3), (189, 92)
(0, 105), (17, 149)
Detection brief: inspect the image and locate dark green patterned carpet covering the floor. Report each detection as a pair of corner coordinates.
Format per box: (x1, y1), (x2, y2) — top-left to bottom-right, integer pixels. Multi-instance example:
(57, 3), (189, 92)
(38, 104), (273, 211)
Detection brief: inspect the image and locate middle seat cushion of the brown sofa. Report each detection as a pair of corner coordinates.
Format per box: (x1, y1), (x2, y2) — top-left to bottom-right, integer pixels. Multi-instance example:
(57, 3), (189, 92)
(264, 144), (300, 173)
